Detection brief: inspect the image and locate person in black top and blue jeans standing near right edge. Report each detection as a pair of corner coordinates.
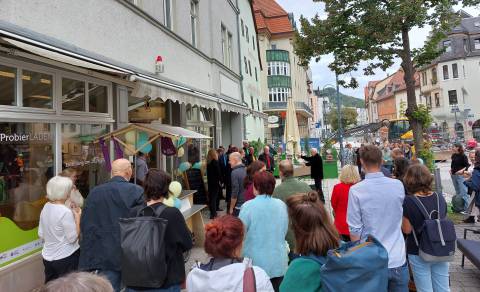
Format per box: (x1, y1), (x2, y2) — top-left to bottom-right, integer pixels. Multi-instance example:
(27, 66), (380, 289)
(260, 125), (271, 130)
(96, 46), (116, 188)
(450, 143), (470, 214)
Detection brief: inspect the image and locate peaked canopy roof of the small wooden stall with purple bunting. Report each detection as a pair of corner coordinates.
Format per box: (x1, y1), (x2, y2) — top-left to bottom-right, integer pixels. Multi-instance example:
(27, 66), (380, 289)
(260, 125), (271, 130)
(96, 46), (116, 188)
(95, 122), (212, 155)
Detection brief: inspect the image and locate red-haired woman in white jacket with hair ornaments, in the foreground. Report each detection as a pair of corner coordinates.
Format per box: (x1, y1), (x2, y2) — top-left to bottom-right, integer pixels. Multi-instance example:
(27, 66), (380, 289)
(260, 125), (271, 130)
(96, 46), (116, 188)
(187, 215), (273, 292)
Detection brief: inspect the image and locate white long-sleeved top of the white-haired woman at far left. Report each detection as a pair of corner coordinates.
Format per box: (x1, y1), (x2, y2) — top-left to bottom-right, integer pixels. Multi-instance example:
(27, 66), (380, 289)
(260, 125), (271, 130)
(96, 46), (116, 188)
(38, 202), (80, 261)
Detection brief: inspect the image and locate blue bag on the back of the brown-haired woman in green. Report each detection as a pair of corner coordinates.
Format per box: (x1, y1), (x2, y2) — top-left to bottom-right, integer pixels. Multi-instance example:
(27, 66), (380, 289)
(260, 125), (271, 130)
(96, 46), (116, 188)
(298, 235), (388, 292)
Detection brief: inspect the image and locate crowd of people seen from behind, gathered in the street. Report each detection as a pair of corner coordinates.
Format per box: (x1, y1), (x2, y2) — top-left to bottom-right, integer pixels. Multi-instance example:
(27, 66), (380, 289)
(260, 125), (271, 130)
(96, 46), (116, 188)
(34, 140), (480, 291)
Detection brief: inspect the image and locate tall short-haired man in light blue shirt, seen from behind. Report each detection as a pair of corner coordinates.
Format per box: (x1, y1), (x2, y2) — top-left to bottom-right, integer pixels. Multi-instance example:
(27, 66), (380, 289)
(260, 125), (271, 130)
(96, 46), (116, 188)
(347, 145), (408, 292)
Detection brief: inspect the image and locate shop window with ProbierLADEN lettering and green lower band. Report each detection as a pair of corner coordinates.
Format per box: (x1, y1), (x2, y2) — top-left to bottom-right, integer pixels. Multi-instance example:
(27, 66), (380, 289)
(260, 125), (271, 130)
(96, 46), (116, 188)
(0, 122), (55, 266)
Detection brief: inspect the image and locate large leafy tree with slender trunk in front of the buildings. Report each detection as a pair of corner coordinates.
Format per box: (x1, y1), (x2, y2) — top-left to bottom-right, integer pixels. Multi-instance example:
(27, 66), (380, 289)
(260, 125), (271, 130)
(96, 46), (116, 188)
(295, 0), (480, 151)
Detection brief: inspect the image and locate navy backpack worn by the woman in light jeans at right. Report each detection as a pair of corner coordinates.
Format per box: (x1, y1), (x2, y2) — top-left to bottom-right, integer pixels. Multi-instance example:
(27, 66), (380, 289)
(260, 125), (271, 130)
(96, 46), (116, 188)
(412, 193), (457, 262)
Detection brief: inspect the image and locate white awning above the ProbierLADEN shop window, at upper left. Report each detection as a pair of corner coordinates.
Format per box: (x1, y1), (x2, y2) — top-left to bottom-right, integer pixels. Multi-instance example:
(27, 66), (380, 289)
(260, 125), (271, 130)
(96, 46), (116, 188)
(2, 36), (134, 74)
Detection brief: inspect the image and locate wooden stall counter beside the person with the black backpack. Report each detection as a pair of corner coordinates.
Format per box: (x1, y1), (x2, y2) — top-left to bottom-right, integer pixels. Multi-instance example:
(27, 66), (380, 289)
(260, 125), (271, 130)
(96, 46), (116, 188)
(178, 190), (207, 247)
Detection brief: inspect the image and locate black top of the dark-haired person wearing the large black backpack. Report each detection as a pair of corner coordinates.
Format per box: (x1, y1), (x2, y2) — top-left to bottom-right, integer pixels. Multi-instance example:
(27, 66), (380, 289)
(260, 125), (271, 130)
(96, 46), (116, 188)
(130, 203), (193, 290)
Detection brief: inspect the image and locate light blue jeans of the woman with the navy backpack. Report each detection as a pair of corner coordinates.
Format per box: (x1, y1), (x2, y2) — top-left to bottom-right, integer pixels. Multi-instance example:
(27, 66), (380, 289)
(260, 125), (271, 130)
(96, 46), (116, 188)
(408, 254), (450, 292)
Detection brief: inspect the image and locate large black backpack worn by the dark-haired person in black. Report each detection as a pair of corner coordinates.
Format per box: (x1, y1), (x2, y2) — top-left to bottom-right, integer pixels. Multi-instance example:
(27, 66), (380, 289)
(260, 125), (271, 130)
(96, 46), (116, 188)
(119, 205), (168, 288)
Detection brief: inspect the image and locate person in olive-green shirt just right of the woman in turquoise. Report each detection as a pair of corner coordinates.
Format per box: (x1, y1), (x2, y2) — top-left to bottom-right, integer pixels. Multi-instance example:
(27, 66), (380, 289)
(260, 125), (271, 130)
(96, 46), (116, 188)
(272, 159), (312, 259)
